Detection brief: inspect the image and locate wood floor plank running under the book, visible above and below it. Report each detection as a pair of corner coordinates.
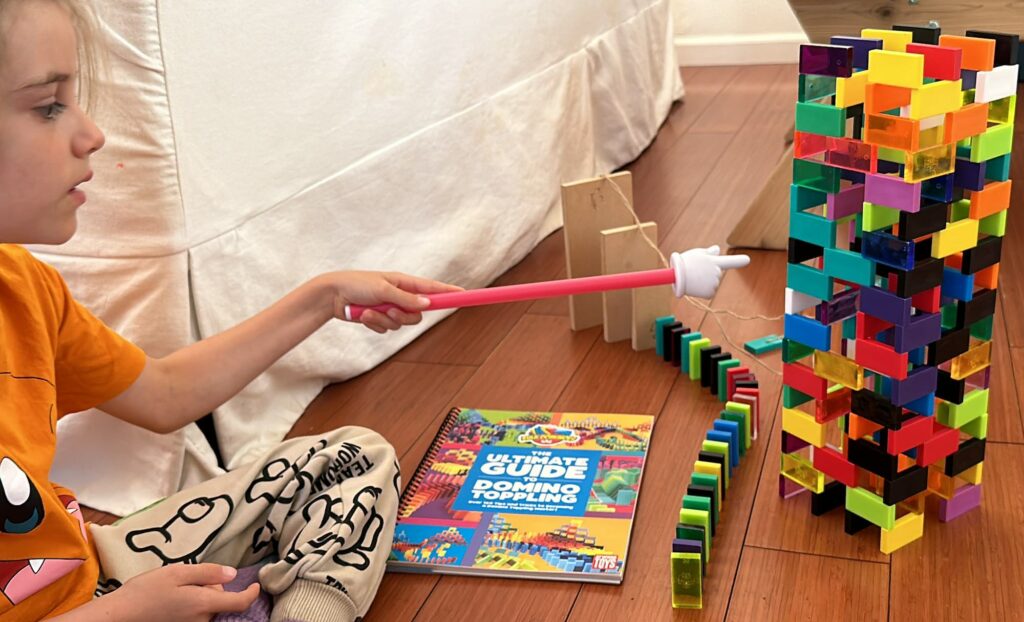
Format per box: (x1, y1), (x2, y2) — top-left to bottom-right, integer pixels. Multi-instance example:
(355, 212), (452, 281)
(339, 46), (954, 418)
(367, 309), (600, 622)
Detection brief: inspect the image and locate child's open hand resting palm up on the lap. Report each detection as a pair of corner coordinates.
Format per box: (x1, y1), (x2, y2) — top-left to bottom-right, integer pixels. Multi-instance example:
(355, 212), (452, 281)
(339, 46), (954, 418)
(103, 564), (259, 622)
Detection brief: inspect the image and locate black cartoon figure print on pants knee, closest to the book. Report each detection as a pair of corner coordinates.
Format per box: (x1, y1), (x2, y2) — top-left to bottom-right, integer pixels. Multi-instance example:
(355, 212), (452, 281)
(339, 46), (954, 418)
(284, 486), (384, 570)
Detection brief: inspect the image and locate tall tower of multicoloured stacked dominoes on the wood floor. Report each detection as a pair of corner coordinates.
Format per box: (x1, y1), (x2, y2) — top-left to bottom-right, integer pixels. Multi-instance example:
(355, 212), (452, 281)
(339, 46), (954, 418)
(779, 27), (1020, 553)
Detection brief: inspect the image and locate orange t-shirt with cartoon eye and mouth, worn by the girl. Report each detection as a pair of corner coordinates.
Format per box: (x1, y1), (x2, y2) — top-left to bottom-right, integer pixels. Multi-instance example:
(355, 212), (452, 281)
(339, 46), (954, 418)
(0, 245), (145, 620)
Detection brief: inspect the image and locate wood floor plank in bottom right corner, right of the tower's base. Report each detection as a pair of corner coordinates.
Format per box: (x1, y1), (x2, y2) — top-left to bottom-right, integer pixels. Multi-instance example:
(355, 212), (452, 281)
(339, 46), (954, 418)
(891, 445), (1024, 621)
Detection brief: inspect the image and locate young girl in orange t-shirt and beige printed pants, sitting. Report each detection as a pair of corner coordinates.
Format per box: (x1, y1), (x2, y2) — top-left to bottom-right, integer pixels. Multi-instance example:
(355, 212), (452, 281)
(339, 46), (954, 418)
(0, 0), (457, 620)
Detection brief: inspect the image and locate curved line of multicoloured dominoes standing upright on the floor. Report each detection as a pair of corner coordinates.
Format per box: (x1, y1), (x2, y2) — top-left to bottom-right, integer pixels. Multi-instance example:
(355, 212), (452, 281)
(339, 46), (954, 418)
(654, 316), (761, 609)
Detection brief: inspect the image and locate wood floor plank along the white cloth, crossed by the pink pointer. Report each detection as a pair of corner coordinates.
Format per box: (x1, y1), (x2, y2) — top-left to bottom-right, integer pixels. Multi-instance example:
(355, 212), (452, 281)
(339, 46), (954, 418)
(394, 231), (565, 365)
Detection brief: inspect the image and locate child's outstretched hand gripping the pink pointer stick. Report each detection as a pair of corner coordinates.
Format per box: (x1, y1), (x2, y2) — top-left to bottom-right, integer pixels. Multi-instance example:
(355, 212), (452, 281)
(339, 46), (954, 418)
(322, 272), (462, 333)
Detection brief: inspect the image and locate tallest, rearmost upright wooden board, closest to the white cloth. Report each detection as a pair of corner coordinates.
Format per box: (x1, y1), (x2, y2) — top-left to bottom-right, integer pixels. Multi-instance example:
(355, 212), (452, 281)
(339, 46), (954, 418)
(562, 171), (633, 330)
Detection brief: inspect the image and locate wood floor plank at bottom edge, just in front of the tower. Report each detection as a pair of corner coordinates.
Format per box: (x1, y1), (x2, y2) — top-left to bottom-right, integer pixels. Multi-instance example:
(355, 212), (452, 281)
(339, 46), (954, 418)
(727, 546), (888, 622)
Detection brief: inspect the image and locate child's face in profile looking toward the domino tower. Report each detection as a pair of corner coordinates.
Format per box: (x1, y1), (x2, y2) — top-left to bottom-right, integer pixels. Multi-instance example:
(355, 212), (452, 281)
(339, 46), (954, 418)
(0, 0), (103, 244)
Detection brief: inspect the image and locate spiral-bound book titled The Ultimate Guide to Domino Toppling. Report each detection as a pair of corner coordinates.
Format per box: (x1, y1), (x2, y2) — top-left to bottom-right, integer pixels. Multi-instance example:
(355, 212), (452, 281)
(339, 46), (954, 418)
(388, 408), (654, 583)
